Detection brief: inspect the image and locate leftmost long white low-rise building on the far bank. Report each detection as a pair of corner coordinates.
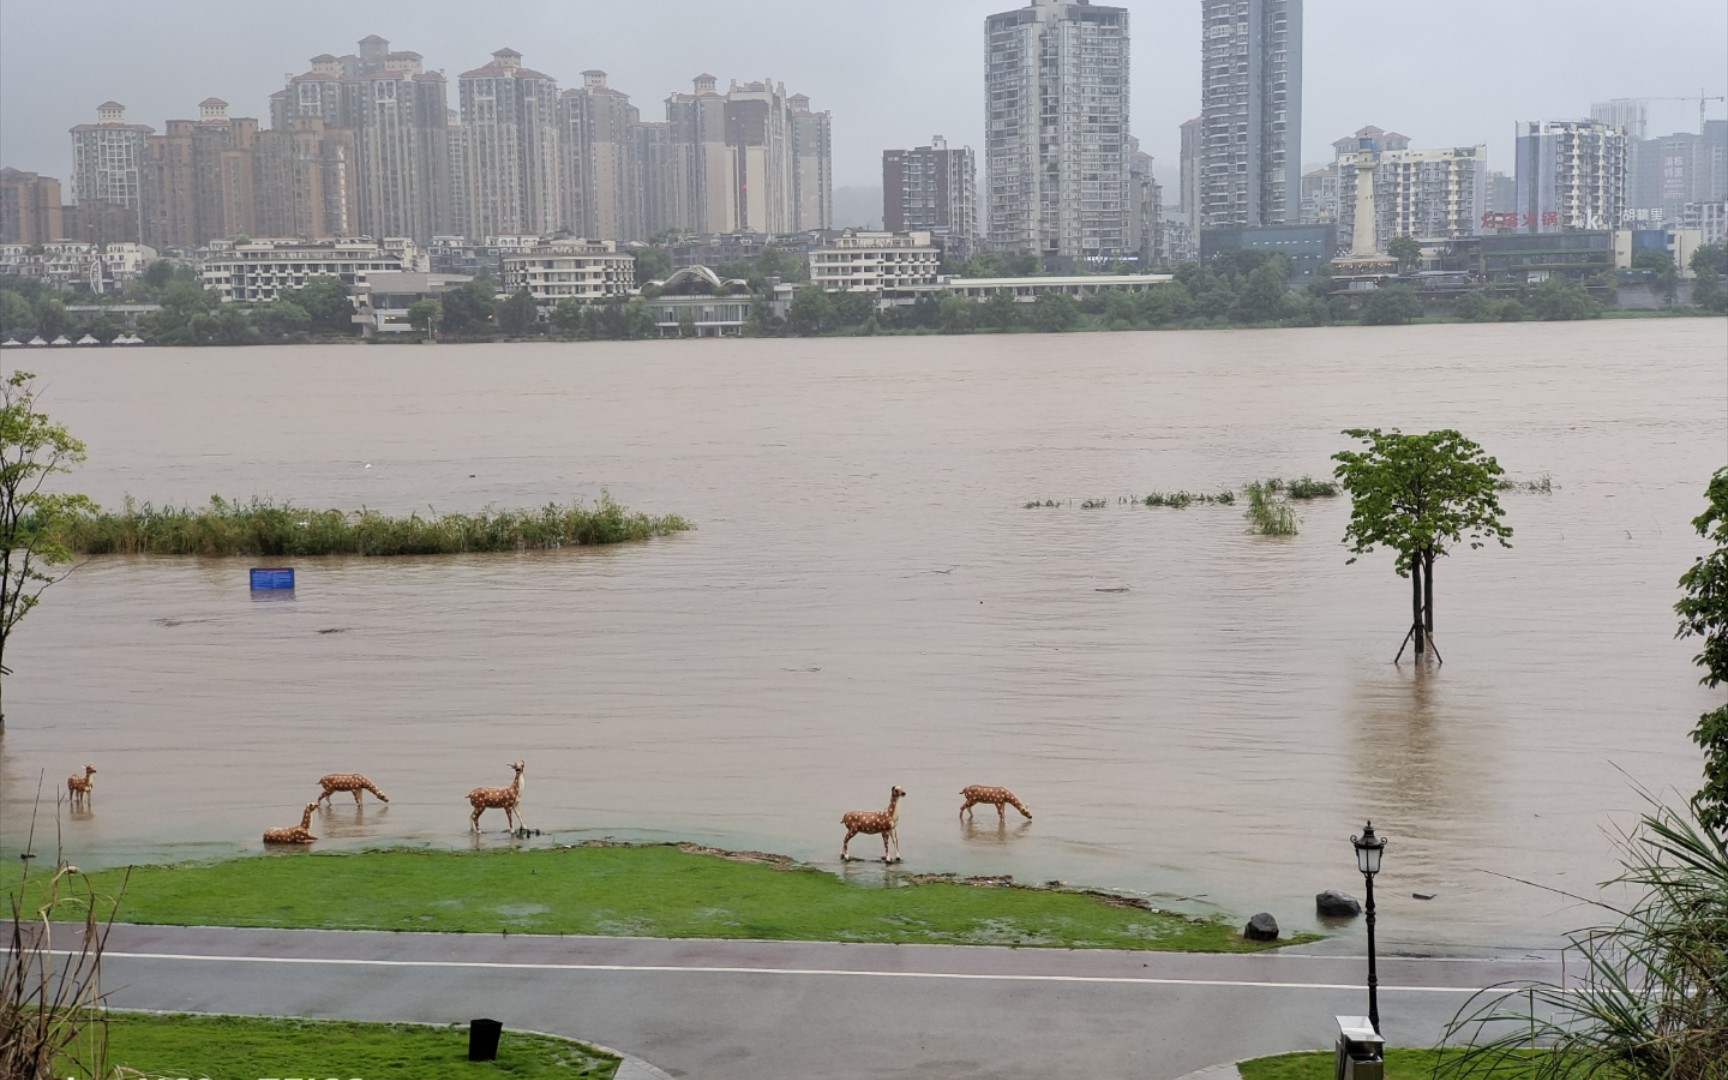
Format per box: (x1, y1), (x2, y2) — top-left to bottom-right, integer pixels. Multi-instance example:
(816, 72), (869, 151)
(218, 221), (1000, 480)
(199, 237), (425, 304)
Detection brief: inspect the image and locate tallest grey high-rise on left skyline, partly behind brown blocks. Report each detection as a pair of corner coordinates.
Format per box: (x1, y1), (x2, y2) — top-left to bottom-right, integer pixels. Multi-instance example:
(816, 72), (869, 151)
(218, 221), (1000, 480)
(270, 35), (454, 244)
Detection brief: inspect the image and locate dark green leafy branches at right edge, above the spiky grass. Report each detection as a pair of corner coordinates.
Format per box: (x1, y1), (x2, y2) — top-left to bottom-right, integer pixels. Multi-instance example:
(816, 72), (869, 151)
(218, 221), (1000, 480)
(1674, 467), (1728, 836)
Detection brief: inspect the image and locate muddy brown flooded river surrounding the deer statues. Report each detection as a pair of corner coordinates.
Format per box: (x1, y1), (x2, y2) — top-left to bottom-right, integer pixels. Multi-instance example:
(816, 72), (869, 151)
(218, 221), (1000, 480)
(0, 320), (1728, 949)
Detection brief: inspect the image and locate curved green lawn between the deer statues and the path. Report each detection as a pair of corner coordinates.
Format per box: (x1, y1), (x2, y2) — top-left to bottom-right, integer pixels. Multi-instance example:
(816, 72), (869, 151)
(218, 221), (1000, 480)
(10, 845), (1312, 952)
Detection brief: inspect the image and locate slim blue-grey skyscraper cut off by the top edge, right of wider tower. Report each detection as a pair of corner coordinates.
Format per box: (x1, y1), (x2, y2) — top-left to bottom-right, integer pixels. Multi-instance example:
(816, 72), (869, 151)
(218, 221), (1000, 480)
(1199, 0), (1301, 228)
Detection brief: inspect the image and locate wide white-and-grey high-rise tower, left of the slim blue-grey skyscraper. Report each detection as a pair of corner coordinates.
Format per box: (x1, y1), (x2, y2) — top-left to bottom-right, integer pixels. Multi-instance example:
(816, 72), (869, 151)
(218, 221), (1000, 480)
(985, 0), (1132, 261)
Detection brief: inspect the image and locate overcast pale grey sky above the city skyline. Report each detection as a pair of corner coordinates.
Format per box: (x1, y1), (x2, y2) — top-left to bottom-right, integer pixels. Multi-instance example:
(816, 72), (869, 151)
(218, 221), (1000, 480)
(0, 0), (1728, 202)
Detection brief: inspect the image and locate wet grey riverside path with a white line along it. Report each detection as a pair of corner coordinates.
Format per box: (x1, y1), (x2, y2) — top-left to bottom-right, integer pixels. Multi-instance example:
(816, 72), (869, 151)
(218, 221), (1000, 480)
(87, 926), (1560, 1080)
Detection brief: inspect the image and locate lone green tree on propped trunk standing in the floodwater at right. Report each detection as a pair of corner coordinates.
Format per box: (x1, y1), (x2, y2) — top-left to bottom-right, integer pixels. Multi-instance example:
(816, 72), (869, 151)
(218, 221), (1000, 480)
(1332, 427), (1512, 658)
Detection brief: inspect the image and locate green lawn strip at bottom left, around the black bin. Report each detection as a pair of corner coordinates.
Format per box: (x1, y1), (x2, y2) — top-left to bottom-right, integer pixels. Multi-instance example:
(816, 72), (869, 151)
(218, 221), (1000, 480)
(55, 1013), (619, 1080)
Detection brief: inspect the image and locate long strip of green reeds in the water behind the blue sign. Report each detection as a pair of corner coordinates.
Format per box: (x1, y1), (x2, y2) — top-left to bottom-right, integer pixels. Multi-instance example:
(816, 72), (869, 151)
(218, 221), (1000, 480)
(57, 492), (695, 558)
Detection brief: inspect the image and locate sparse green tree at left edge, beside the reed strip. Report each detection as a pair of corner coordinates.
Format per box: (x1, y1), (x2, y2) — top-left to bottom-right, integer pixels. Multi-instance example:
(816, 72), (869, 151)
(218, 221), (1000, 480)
(0, 372), (95, 721)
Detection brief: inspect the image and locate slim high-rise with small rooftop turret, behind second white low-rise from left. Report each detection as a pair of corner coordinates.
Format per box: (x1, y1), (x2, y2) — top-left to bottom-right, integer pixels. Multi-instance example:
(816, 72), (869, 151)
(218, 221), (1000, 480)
(558, 71), (646, 240)
